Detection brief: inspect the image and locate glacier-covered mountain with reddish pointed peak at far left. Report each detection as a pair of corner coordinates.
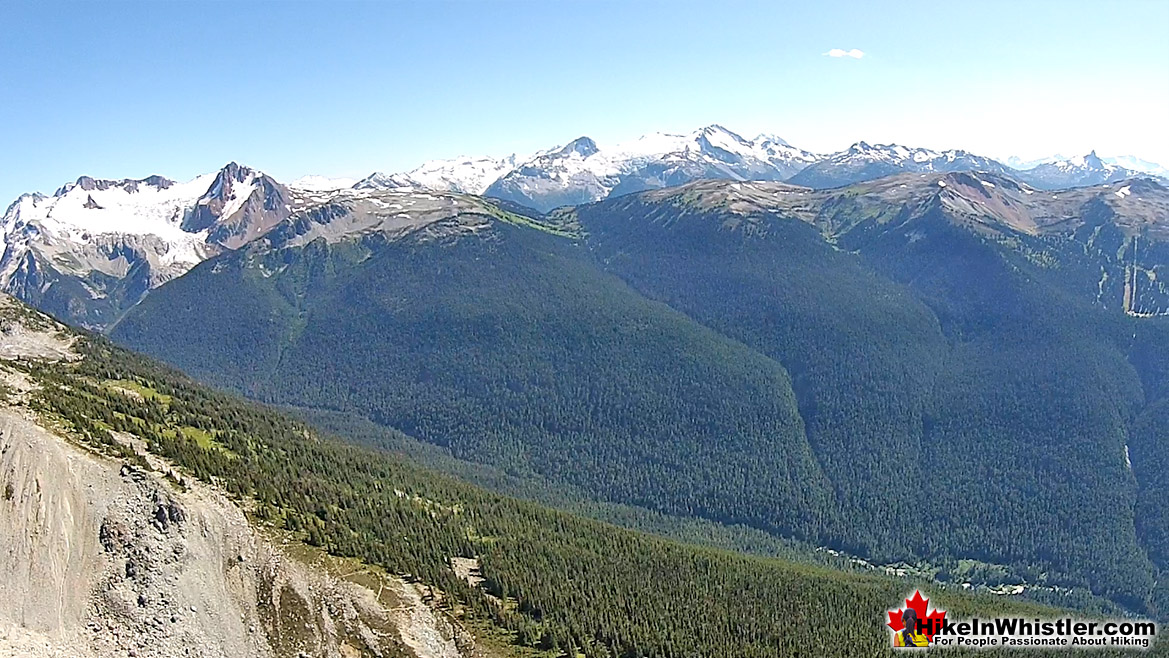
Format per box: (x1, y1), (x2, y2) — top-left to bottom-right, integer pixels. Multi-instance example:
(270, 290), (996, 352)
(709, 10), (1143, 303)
(0, 162), (291, 326)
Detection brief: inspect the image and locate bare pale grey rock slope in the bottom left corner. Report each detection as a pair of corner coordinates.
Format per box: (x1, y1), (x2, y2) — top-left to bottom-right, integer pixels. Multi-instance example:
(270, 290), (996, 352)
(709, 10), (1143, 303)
(0, 297), (472, 658)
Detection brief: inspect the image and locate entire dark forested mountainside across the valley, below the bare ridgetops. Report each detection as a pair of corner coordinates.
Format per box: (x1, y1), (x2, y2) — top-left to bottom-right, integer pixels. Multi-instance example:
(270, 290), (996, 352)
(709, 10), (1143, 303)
(112, 181), (1169, 614)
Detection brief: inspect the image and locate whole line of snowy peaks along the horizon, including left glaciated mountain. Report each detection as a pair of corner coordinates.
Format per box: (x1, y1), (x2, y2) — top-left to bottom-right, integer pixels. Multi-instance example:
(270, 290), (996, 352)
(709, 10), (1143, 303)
(0, 125), (1164, 328)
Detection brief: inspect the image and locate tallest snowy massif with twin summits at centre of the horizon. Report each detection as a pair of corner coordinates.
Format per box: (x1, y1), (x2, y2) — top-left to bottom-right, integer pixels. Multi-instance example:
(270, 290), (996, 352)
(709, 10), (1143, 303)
(486, 125), (817, 210)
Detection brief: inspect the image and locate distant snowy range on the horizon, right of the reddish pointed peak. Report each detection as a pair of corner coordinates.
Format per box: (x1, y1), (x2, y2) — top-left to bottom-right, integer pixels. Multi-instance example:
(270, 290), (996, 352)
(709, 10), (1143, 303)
(357, 125), (1167, 206)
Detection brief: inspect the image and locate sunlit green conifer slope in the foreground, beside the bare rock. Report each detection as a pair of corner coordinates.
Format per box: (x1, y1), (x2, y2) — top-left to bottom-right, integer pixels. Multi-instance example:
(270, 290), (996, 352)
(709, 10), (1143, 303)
(20, 339), (1159, 658)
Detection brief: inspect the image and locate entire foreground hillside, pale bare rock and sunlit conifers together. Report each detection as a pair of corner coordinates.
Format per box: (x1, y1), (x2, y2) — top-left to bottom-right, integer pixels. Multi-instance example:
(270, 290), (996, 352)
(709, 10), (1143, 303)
(0, 294), (1150, 658)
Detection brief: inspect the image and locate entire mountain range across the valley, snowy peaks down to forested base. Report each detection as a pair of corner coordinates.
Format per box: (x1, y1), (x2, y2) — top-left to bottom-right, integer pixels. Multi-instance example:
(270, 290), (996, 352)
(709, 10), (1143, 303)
(0, 120), (1169, 614)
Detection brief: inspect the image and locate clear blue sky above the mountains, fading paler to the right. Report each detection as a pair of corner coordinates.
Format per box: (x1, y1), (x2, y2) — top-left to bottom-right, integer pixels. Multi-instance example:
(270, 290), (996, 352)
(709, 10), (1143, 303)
(0, 0), (1169, 201)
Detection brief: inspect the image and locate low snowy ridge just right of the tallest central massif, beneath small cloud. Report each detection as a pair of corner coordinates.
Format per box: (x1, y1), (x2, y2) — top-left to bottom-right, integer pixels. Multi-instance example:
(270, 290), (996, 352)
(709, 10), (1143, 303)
(788, 141), (1010, 188)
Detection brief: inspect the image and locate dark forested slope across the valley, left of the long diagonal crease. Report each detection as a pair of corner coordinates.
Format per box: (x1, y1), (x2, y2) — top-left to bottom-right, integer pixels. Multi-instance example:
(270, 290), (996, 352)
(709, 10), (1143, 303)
(115, 223), (836, 540)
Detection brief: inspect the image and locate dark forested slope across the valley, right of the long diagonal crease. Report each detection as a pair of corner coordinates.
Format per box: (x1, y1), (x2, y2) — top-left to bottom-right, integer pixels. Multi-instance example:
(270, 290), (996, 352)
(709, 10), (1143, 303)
(573, 191), (1169, 608)
